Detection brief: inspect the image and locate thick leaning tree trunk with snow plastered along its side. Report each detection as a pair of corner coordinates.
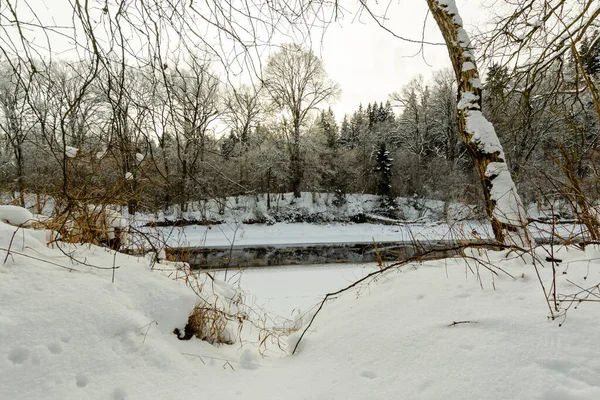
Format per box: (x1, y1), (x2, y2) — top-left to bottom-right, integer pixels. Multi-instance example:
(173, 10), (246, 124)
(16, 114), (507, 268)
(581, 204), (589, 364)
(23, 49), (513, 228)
(427, 0), (533, 247)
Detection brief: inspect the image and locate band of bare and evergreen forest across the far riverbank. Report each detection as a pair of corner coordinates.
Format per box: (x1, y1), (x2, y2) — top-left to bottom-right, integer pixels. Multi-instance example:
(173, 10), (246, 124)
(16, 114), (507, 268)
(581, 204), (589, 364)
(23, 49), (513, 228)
(0, 39), (600, 219)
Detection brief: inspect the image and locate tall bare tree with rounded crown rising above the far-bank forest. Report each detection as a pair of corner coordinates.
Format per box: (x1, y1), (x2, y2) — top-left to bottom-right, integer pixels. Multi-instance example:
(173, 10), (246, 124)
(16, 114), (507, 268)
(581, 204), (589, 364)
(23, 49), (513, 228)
(263, 44), (339, 198)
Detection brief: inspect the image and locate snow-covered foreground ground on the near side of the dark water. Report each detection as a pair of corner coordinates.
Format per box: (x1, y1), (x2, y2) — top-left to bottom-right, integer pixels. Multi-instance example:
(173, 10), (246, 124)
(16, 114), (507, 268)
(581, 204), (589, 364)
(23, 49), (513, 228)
(0, 216), (600, 400)
